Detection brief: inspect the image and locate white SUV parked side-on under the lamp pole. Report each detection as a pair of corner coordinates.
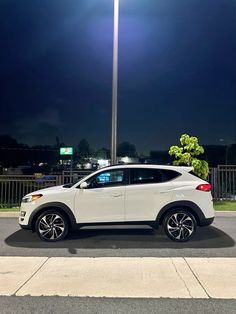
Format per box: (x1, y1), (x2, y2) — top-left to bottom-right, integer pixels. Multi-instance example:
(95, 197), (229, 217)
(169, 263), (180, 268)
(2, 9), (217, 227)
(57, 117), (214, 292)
(19, 164), (214, 242)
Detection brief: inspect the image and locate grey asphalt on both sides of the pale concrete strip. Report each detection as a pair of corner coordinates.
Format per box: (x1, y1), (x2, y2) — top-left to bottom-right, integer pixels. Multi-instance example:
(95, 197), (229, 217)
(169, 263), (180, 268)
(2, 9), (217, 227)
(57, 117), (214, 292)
(0, 213), (236, 314)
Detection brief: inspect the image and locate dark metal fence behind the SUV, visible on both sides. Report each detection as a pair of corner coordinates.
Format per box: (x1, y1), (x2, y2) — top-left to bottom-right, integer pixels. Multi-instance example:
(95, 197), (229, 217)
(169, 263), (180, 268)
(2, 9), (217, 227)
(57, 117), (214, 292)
(0, 165), (236, 208)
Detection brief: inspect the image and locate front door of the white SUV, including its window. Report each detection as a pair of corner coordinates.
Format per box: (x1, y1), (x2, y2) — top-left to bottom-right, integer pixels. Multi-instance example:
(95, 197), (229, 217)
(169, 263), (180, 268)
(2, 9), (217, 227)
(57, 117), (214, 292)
(75, 169), (127, 223)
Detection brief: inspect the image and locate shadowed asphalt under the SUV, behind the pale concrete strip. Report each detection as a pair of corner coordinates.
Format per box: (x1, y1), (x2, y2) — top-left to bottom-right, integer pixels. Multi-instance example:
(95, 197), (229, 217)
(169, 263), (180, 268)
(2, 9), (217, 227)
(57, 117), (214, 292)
(0, 213), (236, 257)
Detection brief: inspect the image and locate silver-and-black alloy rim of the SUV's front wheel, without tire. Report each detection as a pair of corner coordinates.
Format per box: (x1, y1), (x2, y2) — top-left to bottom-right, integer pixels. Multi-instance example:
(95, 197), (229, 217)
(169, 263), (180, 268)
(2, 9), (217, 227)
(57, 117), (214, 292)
(38, 214), (65, 240)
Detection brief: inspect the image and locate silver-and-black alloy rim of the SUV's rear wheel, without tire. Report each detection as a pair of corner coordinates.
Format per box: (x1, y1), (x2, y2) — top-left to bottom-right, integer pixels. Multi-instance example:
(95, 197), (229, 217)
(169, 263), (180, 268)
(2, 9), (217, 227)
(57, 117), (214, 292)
(167, 213), (194, 240)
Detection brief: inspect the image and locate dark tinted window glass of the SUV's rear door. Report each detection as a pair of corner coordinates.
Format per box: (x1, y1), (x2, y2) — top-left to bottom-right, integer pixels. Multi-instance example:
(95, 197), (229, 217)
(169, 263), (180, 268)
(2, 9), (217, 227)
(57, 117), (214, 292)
(130, 168), (162, 184)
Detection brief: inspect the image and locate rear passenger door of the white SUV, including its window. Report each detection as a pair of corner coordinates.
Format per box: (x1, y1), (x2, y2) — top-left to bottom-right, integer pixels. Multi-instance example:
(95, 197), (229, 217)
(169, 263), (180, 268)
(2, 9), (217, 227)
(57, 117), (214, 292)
(125, 167), (173, 221)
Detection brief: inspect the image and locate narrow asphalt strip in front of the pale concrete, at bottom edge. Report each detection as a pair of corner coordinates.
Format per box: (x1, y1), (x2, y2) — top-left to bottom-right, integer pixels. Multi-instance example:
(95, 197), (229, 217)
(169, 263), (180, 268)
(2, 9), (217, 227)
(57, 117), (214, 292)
(0, 297), (236, 314)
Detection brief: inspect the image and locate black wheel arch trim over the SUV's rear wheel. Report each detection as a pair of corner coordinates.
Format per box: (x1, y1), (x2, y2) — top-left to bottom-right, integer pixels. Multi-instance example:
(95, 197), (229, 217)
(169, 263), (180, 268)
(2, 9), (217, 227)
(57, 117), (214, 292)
(156, 201), (205, 226)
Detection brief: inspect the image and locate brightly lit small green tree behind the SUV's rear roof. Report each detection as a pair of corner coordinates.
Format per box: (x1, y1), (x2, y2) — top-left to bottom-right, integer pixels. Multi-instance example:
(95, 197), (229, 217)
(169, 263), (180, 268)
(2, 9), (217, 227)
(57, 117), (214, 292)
(169, 134), (209, 179)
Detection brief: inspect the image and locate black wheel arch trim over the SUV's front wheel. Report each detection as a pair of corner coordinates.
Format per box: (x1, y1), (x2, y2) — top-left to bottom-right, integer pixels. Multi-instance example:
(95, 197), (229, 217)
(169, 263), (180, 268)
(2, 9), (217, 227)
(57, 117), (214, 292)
(29, 202), (76, 231)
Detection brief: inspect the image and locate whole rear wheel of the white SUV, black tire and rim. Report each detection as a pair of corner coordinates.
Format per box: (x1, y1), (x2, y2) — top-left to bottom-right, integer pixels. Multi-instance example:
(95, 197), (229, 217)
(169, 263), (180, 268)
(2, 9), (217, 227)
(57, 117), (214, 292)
(163, 208), (197, 242)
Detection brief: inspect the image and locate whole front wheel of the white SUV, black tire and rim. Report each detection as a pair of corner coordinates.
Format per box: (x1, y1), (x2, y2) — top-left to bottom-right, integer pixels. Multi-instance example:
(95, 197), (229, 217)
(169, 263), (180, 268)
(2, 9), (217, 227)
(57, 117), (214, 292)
(35, 209), (69, 242)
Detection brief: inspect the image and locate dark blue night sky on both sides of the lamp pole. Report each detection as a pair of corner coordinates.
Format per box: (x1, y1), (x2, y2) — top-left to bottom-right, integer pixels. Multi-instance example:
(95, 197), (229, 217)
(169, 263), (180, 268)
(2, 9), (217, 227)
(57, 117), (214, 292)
(0, 0), (236, 153)
